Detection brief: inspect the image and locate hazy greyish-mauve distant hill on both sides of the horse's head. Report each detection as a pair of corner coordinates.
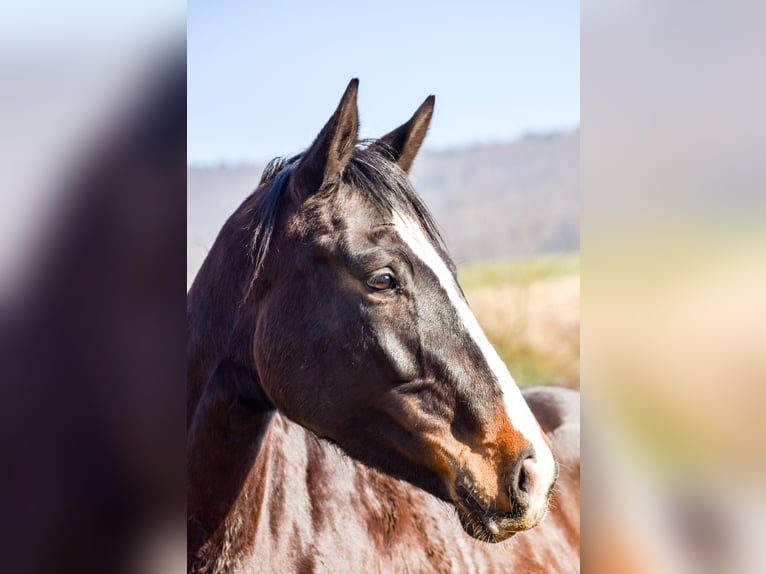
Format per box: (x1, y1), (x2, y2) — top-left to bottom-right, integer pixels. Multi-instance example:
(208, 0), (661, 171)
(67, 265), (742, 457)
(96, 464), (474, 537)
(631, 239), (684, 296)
(187, 130), (580, 284)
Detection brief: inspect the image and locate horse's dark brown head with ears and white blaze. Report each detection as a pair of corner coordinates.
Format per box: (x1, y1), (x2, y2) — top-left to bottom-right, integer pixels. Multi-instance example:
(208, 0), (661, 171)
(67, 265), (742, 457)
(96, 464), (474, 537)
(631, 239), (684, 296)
(245, 80), (557, 542)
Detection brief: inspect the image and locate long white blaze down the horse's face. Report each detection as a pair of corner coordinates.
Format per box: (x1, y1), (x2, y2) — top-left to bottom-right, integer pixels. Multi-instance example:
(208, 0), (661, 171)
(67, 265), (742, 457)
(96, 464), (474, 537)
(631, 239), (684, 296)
(393, 213), (555, 494)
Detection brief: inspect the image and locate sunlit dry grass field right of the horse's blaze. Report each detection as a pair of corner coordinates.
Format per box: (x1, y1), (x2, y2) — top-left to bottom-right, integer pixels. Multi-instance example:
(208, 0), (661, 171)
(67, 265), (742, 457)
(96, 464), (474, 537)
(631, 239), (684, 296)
(459, 253), (580, 388)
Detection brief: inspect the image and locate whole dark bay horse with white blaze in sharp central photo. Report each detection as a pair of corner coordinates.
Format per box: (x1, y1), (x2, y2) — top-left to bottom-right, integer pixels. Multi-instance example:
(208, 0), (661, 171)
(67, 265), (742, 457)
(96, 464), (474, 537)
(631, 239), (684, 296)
(187, 80), (579, 573)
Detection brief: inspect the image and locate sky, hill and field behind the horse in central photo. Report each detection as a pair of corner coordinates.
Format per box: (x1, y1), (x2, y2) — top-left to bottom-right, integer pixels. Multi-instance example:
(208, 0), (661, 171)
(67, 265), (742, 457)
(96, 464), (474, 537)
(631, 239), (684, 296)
(187, 1), (580, 388)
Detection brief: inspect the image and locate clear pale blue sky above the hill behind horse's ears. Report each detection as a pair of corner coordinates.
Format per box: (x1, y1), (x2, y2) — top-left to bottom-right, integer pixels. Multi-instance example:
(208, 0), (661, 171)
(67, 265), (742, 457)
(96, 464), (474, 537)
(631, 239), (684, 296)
(187, 0), (580, 163)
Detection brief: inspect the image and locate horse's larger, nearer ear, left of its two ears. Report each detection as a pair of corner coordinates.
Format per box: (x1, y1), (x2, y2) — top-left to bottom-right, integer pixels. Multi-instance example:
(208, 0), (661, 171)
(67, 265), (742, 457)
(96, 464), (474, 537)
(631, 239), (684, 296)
(292, 78), (359, 201)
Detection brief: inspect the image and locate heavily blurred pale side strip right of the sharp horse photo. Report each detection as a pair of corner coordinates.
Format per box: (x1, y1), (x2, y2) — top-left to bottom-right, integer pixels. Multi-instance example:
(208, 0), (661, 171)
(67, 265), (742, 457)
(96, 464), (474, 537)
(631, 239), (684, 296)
(580, 1), (766, 574)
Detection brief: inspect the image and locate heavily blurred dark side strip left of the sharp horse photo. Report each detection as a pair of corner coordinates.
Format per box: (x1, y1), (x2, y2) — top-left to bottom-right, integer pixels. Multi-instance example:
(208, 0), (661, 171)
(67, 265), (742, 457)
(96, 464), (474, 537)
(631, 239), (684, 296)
(0, 2), (186, 573)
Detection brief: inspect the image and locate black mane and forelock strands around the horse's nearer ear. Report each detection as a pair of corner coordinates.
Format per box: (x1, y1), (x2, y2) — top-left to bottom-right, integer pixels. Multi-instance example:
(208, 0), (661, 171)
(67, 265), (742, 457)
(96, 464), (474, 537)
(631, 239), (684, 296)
(247, 140), (447, 294)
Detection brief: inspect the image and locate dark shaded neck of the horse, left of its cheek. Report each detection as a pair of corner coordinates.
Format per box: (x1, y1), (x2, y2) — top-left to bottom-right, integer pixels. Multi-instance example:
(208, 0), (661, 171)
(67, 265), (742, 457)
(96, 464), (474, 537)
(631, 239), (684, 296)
(186, 194), (284, 568)
